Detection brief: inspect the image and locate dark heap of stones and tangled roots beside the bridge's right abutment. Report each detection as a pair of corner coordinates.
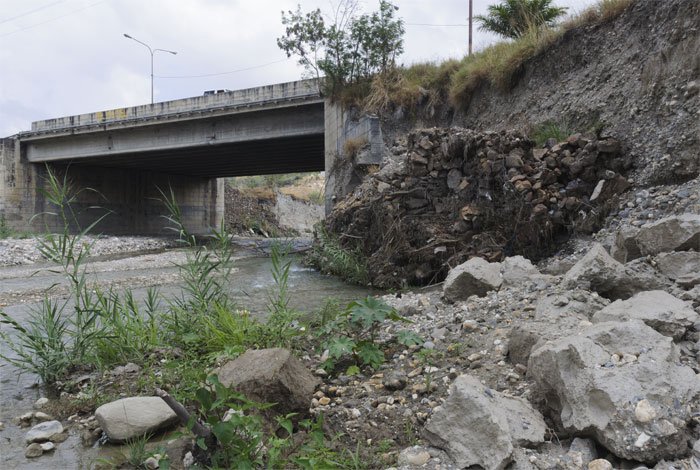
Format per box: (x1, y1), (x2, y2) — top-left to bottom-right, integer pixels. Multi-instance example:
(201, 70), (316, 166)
(327, 128), (631, 287)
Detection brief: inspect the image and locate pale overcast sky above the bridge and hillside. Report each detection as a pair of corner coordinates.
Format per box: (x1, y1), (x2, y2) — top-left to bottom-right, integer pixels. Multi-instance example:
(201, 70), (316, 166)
(0, 0), (595, 137)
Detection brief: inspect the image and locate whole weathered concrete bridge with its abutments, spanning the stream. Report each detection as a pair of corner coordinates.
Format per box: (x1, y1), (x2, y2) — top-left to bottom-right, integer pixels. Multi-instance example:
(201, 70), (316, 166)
(0, 80), (383, 234)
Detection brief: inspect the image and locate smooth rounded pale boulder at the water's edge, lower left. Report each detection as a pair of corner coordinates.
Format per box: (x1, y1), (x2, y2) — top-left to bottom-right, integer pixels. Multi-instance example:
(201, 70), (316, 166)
(95, 397), (178, 442)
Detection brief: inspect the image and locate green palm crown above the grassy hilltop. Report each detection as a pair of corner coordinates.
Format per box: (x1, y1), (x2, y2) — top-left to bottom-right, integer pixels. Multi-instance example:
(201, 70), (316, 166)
(474, 0), (567, 39)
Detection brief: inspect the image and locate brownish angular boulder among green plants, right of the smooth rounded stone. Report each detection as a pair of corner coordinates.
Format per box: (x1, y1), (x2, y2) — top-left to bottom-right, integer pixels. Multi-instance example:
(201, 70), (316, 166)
(215, 348), (319, 416)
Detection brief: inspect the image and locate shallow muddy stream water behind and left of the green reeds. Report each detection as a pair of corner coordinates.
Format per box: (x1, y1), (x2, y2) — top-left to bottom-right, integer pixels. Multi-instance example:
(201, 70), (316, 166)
(0, 251), (368, 470)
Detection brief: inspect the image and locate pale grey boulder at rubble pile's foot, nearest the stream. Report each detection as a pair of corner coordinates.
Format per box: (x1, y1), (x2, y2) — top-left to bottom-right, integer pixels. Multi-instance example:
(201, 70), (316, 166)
(442, 258), (502, 302)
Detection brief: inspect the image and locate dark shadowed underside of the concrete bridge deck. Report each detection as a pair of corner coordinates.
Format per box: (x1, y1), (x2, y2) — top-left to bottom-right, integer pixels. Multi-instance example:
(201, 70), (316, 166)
(56, 134), (324, 178)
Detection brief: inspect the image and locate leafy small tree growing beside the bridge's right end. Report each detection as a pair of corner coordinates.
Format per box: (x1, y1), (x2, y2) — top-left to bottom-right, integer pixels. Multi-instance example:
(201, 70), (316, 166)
(277, 0), (404, 95)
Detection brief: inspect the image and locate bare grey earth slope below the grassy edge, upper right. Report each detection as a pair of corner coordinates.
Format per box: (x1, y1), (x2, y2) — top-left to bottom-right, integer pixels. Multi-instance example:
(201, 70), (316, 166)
(452, 0), (700, 185)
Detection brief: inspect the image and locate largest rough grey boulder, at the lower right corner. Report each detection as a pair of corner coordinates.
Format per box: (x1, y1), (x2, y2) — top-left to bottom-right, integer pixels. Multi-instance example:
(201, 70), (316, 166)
(528, 320), (700, 463)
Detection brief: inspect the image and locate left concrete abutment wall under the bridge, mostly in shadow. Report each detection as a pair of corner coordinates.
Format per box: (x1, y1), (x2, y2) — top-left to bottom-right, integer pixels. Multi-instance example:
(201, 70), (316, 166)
(0, 139), (224, 235)
